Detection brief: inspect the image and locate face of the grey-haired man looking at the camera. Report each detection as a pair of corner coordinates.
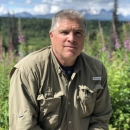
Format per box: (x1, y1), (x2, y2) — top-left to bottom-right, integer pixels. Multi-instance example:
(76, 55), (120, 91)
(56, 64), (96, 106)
(49, 19), (85, 65)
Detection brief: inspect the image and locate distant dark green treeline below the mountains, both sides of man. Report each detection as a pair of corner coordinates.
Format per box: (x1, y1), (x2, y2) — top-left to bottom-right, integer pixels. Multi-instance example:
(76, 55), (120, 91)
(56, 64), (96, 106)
(0, 16), (127, 51)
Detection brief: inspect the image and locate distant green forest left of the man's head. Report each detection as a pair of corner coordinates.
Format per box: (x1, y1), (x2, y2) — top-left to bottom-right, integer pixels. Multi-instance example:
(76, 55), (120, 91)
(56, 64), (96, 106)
(0, 17), (51, 52)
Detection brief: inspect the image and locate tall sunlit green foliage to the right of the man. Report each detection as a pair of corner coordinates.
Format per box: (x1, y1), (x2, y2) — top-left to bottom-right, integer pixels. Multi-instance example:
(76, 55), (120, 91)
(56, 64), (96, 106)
(85, 23), (130, 130)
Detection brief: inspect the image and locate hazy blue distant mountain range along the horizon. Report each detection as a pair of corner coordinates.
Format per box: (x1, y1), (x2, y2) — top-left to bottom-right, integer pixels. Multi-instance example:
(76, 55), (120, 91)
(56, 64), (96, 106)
(0, 8), (130, 21)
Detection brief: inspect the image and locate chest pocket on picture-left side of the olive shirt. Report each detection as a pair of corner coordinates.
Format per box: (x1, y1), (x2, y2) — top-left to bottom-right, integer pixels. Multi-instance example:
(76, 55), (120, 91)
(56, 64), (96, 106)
(37, 91), (63, 130)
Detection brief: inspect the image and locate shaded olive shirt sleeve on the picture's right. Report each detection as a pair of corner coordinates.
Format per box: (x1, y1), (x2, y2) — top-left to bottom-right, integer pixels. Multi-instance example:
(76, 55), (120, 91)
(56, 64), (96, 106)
(89, 66), (112, 130)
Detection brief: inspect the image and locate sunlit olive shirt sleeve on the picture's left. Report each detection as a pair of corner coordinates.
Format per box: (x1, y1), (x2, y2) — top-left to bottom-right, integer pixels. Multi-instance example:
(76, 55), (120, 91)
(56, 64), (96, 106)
(9, 68), (43, 130)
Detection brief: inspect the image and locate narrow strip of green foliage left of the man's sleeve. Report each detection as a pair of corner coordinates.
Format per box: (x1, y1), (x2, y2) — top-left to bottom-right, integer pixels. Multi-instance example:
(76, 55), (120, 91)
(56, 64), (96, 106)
(0, 54), (16, 130)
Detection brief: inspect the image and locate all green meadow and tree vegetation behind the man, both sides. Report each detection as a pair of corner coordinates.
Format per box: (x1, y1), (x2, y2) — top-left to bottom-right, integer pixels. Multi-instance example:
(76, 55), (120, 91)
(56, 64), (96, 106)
(0, 18), (130, 130)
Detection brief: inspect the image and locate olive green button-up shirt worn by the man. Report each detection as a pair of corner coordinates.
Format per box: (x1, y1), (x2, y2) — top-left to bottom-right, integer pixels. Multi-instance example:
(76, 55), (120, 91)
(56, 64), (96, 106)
(9, 46), (112, 130)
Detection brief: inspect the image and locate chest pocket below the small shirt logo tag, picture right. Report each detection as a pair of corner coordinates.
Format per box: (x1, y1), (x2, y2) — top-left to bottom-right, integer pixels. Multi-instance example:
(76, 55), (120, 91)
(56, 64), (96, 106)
(77, 84), (103, 117)
